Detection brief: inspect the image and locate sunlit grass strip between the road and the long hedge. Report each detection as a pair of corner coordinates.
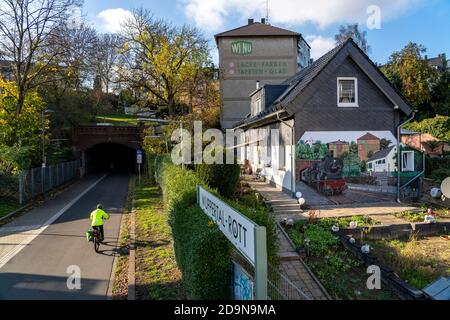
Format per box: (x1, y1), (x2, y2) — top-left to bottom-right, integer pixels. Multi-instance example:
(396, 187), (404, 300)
(135, 180), (185, 300)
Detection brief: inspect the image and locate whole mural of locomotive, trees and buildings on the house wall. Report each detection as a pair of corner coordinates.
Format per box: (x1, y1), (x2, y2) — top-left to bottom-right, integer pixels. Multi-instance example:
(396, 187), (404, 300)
(296, 131), (396, 196)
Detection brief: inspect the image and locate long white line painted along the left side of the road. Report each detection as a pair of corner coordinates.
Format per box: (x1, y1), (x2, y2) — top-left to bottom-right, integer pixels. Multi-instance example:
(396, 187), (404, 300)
(0, 174), (108, 269)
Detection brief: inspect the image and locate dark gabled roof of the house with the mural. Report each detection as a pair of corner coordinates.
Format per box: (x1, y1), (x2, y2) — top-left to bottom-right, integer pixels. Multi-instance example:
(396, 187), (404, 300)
(235, 38), (412, 127)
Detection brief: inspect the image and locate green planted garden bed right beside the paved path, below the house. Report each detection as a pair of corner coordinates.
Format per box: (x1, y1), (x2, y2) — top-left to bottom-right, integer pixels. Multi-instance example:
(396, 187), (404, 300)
(287, 219), (399, 300)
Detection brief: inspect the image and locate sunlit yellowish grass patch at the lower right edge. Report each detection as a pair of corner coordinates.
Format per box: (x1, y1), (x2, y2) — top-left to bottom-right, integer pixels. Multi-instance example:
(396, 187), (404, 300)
(371, 236), (450, 289)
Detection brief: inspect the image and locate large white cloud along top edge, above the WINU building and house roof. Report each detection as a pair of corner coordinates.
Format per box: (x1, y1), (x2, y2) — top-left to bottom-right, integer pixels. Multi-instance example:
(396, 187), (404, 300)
(180, 0), (424, 31)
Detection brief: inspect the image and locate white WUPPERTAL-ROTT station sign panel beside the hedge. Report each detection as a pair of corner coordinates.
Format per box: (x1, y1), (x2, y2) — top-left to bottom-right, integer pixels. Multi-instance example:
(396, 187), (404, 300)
(197, 187), (257, 265)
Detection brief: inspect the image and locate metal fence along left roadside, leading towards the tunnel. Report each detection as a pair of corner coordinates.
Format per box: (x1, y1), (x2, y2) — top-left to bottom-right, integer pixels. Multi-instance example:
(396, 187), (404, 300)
(0, 160), (80, 204)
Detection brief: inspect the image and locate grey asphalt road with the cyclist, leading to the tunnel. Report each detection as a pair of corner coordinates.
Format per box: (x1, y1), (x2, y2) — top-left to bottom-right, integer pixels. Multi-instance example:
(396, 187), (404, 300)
(0, 175), (129, 300)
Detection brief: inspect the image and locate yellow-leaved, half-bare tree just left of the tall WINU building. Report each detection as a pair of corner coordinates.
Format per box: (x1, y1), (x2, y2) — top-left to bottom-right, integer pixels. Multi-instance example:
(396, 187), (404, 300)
(119, 9), (209, 115)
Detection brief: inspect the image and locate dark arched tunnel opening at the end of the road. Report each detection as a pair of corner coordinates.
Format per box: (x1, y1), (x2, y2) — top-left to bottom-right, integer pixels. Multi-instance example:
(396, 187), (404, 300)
(86, 143), (136, 174)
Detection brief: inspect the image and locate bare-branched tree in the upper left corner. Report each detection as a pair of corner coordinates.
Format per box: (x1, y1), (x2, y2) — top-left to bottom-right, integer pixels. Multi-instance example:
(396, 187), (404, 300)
(0, 0), (82, 115)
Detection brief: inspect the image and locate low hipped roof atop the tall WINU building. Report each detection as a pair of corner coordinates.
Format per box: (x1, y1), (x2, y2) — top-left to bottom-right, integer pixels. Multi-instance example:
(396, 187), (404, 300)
(214, 22), (300, 42)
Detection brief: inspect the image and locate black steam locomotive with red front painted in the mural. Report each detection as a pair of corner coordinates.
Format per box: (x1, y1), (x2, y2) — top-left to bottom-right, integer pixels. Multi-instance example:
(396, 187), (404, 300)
(300, 155), (346, 196)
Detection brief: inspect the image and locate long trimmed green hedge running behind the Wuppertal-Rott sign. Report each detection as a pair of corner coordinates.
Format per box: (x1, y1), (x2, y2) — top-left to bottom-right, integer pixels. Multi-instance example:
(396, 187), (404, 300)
(154, 156), (278, 300)
